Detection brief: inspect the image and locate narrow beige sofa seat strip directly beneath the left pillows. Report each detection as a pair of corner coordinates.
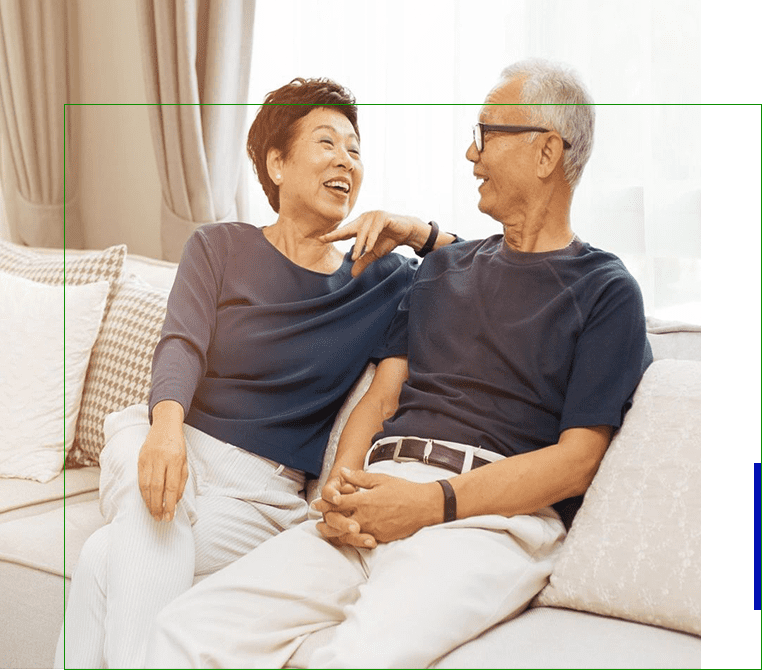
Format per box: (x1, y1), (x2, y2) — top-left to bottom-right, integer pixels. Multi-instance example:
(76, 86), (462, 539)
(0, 467), (100, 523)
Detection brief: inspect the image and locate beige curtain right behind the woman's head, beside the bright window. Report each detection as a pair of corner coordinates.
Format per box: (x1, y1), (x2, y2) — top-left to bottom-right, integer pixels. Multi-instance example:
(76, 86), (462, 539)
(138, 0), (254, 261)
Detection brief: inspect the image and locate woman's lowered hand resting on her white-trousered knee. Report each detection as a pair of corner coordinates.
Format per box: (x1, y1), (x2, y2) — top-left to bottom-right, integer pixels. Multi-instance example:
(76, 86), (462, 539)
(138, 400), (188, 521)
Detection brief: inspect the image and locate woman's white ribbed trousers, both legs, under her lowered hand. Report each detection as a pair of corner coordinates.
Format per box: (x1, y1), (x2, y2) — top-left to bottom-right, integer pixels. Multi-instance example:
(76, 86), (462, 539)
(54, 405), (307, 668)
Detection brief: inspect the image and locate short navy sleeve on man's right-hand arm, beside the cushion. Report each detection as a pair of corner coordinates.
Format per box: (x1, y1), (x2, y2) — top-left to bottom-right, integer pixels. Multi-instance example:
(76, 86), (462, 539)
(560, 270), (653, 431)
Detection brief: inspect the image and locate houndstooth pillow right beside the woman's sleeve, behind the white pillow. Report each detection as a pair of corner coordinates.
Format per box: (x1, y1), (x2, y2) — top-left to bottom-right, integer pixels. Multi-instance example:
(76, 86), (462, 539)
(66, 276), (169, 466)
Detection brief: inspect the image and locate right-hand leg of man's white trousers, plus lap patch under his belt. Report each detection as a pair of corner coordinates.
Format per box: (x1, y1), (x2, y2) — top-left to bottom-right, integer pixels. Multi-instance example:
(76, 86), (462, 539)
(310, 461), (566, 668)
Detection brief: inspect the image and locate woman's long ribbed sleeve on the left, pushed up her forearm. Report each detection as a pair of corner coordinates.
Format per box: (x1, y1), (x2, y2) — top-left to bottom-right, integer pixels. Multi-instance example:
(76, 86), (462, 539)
(148, 230), (223, 419)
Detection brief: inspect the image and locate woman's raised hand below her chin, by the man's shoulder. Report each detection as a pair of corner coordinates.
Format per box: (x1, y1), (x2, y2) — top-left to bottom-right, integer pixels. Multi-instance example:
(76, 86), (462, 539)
(320, 211), (424, 277)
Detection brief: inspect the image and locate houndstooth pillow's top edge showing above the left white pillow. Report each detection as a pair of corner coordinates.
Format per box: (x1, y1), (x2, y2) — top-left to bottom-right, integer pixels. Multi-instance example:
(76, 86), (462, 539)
(0, 241), (127, 300)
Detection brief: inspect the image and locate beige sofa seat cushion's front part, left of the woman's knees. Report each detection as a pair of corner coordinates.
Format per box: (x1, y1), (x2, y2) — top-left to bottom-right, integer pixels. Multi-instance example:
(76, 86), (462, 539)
(0, 500), (105, 579)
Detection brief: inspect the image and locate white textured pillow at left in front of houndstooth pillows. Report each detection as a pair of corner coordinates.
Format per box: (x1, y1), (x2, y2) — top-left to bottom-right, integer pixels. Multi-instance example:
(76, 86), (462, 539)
(0, 272), (109, 482)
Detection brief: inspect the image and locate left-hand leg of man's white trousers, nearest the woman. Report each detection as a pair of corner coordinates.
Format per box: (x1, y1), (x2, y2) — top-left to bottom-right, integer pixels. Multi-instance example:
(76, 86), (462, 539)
(146, 521), (367, 668)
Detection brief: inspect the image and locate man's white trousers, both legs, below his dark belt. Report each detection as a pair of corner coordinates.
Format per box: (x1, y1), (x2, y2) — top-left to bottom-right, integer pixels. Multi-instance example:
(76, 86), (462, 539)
(146, 461), (566, 668)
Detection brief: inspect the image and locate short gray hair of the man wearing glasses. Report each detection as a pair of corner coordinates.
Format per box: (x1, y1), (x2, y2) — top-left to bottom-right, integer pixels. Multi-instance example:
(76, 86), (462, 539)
(500, 58), (595, 191)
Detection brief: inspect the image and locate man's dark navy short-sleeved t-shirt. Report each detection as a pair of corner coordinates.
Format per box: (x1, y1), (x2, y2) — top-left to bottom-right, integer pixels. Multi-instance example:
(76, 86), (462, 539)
(377, 235), (652, 456)
